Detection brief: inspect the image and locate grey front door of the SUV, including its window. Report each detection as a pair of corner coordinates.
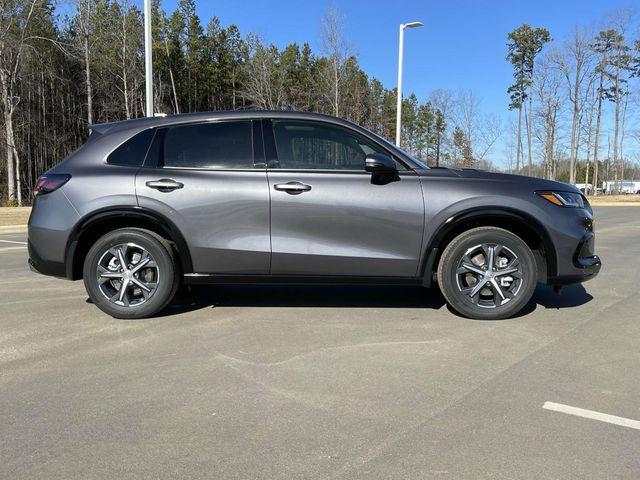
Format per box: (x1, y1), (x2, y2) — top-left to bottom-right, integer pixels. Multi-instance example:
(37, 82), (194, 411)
(265, 119), (424, 277)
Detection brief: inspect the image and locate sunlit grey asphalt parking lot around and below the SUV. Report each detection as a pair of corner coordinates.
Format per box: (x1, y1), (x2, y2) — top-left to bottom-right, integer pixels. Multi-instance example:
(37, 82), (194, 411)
(0, 207), (640, 479)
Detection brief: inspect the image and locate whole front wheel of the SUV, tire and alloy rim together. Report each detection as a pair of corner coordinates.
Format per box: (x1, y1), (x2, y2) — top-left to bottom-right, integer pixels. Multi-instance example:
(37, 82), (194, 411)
(438, 227), (537, 320)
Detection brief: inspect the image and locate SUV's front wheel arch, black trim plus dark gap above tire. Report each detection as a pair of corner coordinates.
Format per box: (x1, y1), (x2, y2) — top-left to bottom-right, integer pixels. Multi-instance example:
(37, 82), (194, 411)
(420, 207), (557, 287)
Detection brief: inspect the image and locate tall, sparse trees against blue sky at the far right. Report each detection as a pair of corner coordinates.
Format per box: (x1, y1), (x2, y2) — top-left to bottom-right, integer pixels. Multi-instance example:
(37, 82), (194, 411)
(507, 8), (640, 194)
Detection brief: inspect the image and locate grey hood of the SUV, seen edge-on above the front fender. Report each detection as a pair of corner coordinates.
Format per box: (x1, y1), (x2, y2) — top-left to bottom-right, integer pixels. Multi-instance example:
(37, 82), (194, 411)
(416, 167), (581, 193)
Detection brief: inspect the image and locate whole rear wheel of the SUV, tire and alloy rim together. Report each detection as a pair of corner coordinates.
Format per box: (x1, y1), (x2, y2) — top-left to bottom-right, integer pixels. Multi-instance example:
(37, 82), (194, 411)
(83, 228), (180, 319)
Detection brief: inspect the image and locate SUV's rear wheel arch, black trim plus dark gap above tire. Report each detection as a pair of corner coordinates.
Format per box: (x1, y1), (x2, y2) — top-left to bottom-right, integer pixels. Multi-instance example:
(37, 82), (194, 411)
(65, 206), (193, 280)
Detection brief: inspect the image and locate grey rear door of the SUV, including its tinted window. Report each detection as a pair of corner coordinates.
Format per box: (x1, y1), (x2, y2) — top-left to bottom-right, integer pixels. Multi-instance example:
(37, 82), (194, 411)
(136, 120), (271, 274)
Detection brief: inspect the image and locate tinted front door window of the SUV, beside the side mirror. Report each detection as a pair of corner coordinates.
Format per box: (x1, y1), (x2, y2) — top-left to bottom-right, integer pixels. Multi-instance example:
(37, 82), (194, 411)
(273, 120), (396, 171)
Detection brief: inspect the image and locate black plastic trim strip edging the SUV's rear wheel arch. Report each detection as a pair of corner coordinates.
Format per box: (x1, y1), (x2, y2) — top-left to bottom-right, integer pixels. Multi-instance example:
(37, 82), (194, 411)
(65, 206), (193, 280)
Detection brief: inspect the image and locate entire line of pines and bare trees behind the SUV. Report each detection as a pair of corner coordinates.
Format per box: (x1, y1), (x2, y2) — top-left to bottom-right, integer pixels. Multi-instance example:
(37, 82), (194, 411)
(0, 0), (640, 205)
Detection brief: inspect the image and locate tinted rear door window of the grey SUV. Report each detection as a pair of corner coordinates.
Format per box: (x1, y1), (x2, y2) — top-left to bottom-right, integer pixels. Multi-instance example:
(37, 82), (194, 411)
(164, 121), (253, 168)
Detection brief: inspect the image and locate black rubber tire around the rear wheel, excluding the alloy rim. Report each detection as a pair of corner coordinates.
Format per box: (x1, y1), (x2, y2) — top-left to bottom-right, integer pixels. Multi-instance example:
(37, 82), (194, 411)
(83, 229), (177, 318)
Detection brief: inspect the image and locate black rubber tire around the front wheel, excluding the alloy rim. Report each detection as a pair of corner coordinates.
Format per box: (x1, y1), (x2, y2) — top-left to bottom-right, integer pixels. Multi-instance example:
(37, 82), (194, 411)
(438, 227), (537, 320)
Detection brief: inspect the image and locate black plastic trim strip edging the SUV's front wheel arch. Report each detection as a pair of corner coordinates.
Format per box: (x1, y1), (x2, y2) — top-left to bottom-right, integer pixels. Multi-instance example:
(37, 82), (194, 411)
(420, 206), (557, 287)
